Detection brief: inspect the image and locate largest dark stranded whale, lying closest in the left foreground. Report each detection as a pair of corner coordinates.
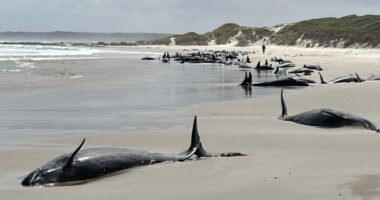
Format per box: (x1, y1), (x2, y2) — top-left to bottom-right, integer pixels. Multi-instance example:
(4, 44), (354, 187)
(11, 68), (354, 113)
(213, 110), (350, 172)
(21, 116), (244, 186)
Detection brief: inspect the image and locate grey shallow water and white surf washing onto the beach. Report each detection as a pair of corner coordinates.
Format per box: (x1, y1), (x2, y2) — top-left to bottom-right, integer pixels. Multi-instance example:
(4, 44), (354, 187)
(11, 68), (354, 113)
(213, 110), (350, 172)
(0, 45), (279, 148)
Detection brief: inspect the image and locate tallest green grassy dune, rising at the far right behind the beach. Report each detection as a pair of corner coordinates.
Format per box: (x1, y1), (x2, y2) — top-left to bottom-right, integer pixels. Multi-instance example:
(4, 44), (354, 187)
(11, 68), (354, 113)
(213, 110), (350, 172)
(272, 15), (380, 47)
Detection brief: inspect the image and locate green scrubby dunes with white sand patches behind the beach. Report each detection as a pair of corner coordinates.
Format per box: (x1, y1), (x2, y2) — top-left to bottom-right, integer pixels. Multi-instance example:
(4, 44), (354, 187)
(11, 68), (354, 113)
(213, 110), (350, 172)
(141, 15), (380, 48)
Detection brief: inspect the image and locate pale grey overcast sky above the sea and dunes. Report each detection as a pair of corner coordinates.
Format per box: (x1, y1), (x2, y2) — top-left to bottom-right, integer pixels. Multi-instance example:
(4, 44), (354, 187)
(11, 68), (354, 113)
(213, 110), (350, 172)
(0, 0), (380, 33)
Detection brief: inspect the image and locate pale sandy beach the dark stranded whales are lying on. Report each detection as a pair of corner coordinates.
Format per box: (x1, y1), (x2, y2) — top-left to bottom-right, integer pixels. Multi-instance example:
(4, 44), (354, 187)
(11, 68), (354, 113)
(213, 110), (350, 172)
(0, 46), (380, 200)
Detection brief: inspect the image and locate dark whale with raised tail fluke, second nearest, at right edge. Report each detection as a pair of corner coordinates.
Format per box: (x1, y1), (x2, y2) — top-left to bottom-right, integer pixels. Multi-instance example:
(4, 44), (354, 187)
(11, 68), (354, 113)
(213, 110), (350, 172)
(280, 90), (380, 132)
